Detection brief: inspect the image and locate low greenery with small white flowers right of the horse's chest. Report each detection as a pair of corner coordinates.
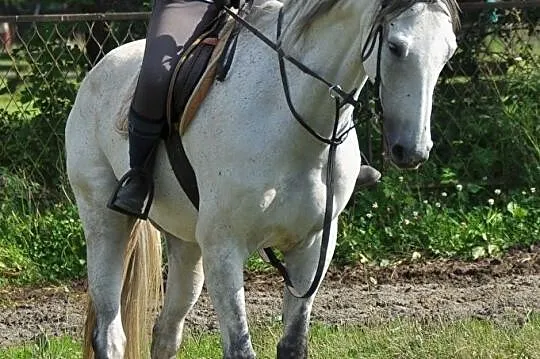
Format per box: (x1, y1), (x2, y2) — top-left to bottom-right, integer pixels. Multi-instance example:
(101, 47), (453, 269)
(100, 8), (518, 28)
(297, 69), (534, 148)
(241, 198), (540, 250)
(336, 170), (540, 264)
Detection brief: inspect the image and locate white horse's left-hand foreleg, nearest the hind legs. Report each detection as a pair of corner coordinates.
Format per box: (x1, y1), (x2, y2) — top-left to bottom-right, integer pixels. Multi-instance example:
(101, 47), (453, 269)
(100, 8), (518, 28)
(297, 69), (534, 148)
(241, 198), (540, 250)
(197, 222), (255, 359)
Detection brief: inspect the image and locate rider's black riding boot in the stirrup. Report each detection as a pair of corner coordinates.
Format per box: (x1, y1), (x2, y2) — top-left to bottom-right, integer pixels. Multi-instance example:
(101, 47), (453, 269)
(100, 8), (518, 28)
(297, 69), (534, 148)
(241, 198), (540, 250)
(107, 109), (164, 219)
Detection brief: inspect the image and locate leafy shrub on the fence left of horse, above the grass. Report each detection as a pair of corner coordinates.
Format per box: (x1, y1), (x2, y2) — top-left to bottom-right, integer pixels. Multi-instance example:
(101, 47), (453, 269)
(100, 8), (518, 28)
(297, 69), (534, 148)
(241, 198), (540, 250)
(0, 24), (85, 190)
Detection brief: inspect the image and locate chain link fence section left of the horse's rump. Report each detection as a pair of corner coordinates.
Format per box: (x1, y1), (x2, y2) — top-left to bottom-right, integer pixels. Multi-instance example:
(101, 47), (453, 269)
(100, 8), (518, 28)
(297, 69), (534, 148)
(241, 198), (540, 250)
(0, 13), (149, 196)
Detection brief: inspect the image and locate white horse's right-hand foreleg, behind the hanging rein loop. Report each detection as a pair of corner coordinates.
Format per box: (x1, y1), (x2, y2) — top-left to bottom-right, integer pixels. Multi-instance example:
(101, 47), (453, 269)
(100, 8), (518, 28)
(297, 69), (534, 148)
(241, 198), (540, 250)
(277, 221), (337, 359)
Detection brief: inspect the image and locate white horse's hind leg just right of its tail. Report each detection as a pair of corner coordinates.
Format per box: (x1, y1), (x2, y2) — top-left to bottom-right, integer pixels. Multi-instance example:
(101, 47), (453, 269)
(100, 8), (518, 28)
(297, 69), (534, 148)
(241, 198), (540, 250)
(152, 234), (204, 359)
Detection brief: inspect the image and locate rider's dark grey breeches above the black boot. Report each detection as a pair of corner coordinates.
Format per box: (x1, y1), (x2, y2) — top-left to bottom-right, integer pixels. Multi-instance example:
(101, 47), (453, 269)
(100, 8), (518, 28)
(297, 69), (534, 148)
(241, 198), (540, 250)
(132, 0), (218, 121)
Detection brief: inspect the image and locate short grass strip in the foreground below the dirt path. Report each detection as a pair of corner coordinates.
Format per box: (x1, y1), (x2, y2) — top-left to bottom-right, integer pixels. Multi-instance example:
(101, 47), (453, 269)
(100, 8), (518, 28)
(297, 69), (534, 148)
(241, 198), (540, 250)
(0, 314), (540, 359)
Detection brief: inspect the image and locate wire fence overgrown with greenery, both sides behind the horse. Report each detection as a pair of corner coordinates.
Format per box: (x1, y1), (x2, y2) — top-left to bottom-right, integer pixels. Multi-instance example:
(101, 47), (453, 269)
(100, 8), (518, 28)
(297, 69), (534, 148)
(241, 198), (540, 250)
(0, 1), (540, 200)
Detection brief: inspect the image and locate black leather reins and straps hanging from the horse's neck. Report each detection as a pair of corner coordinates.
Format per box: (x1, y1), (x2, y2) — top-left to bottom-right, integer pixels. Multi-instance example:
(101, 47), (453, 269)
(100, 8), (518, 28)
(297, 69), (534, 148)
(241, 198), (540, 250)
(225, 4), (385, 298)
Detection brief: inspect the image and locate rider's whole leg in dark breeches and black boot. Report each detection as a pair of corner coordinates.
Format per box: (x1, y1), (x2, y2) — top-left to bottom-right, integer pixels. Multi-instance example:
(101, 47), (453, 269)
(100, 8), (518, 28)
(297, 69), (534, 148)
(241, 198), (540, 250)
(109, 0), (219, 218)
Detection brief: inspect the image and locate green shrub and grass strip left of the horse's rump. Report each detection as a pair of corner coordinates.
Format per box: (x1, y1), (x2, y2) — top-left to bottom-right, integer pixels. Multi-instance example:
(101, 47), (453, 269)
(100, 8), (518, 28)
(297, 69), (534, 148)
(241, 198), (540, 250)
(0, 24), (86, 283)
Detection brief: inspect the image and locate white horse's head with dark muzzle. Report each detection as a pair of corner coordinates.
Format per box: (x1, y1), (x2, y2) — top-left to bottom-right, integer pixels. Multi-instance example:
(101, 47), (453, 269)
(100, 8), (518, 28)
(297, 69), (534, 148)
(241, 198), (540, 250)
(364, 0), (459, 168)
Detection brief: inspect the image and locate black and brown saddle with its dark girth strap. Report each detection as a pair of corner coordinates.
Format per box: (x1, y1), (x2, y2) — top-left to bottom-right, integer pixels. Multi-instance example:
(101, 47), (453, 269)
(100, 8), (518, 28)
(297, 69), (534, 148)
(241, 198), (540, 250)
(165, 11), (239, 209)
